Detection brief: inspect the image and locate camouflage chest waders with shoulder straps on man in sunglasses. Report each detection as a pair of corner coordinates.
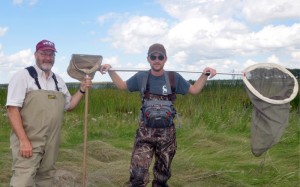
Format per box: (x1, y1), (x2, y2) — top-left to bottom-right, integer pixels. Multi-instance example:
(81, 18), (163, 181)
(129, 72), (177, 187)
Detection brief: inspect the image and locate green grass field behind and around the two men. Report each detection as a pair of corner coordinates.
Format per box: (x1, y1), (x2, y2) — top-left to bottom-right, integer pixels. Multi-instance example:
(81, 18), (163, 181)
(0, 82), (300, 187)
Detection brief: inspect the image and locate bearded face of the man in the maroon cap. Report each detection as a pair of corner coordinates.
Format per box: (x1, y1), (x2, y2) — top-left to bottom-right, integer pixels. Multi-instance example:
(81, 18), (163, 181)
(35, 50), (55, 72)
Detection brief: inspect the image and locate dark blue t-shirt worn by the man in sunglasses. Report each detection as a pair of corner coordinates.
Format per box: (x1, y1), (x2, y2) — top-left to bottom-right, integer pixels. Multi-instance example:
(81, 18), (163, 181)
(126, 71), (190, 95)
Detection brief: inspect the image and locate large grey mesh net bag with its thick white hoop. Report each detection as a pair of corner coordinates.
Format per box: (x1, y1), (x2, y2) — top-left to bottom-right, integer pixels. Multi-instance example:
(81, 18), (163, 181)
(243, 63), (299, 157)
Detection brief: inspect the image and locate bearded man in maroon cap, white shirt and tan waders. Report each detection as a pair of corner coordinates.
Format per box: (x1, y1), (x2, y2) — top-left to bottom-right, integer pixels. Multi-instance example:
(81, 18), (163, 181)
(6, 40), (91, 187)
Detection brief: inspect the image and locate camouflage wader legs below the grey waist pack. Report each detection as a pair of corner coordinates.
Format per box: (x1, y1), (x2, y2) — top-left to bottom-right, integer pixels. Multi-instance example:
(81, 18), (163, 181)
(129, 112), (177, 187)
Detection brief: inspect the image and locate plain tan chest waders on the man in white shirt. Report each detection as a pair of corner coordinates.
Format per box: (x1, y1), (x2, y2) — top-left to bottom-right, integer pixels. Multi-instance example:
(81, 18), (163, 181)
(10, 90), (66, 187)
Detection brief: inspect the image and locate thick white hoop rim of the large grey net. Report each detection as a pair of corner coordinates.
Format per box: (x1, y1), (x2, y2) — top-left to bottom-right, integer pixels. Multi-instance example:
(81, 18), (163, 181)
(243, 63), (299, 104)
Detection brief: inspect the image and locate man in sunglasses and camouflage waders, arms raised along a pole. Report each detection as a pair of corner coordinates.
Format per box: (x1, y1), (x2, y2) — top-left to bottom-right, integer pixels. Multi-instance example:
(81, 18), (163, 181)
(100, 43), (216, 187)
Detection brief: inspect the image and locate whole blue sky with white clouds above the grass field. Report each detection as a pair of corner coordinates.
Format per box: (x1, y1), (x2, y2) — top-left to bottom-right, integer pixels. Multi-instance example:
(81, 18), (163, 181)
(0, 0), (300, 84)
